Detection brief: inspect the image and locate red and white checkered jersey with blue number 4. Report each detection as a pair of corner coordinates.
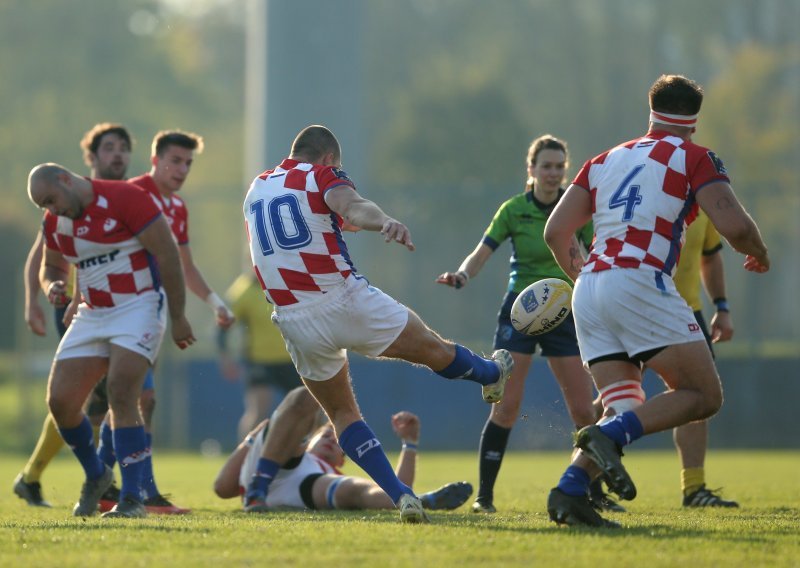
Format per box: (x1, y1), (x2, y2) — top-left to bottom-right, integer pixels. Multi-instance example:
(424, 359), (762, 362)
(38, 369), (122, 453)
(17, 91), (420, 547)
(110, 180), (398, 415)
(573, 131), (729, 275)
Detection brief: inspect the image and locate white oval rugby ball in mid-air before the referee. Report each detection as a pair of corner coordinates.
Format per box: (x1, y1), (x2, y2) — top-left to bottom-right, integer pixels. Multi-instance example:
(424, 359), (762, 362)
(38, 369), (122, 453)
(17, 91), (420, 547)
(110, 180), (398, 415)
(511, 278), (572, 335)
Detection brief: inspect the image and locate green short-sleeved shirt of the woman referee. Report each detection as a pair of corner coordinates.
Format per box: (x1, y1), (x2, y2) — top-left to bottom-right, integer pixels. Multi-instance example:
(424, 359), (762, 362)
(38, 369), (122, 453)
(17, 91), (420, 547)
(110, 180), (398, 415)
(483, 189), (594, 292)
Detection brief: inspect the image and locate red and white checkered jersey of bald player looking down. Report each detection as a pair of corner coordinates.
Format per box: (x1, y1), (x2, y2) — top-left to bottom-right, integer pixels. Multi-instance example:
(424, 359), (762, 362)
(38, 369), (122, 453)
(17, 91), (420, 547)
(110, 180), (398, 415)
(43, 180), (161, 308)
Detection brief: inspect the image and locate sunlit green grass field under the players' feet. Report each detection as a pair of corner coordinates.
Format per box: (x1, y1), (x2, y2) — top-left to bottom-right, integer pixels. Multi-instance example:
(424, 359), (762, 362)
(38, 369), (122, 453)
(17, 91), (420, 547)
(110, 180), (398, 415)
(0, 450), (800, 568)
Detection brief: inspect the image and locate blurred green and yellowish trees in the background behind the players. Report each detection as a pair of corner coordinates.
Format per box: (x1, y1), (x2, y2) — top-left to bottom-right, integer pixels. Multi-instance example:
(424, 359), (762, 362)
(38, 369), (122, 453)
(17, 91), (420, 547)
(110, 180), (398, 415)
(0, 0), (800, 360)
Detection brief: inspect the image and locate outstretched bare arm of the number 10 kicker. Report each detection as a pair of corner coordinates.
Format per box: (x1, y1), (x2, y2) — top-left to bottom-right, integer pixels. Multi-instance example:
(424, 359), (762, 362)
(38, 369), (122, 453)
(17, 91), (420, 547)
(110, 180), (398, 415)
(325, 186), (415, 251)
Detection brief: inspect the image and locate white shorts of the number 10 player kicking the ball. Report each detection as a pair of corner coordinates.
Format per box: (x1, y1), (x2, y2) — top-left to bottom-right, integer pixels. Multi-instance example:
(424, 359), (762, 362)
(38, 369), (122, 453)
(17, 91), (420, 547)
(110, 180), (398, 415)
(272, 277), (408, 381)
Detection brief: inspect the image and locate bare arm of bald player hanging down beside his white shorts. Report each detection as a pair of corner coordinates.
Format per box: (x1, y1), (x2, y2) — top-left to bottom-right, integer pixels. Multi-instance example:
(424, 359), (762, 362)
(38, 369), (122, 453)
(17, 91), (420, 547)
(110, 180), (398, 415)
(137, 215), (195, 349)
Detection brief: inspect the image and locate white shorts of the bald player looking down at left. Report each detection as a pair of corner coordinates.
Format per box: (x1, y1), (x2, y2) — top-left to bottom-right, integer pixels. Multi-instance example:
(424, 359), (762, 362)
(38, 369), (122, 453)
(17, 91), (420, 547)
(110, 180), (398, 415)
(56, 291), (167, 364)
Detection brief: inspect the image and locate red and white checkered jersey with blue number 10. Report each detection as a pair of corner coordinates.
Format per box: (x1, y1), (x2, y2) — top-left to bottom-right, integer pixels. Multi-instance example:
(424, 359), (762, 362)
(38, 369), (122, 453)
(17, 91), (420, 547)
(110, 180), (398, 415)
(244, 158), (355, 306)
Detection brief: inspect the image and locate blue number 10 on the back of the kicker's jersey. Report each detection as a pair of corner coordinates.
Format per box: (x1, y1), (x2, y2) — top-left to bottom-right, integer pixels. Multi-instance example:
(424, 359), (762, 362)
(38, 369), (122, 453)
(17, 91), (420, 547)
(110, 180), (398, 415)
(250, 195), (311, 256)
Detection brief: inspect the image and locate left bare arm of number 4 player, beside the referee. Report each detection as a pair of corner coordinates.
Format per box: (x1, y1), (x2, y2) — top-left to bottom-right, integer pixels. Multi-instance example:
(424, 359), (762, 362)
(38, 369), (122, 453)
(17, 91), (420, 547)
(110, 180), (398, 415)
(544, 184), (592, 282)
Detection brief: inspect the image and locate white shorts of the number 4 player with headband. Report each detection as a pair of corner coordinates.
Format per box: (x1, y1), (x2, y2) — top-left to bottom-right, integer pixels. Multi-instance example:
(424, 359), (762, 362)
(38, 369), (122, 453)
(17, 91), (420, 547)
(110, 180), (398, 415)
(572, 268), (705, 363)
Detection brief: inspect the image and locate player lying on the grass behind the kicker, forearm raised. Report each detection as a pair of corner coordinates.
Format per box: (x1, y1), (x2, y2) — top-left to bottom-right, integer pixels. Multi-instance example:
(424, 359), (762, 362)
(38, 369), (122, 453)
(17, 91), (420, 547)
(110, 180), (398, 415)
(214, 387), (472, 513)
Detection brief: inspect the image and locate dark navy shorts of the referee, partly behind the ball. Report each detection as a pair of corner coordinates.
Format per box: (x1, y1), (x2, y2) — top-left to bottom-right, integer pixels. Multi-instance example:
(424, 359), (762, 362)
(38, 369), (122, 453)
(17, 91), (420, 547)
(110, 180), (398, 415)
(494, 292), (580, 357)
